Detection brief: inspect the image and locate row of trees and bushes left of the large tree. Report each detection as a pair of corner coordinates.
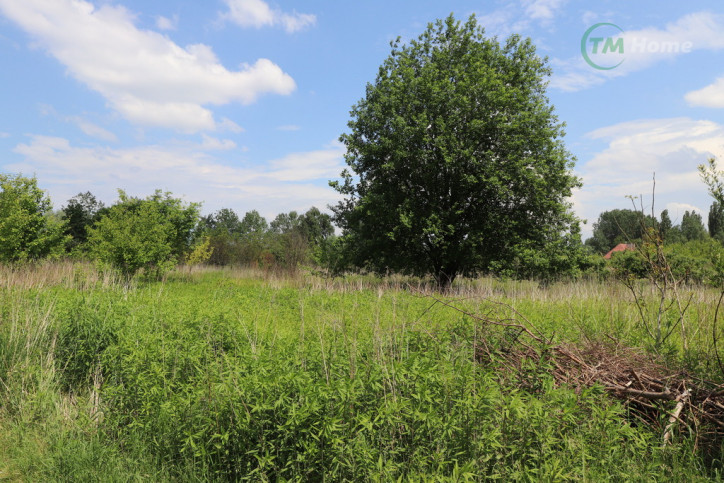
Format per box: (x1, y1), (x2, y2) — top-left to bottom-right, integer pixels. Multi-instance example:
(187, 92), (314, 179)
(0, 175), (336, 277)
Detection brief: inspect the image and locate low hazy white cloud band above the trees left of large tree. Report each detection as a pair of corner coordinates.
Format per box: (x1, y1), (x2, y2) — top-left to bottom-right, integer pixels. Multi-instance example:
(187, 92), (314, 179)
(7, 136), (344, 217)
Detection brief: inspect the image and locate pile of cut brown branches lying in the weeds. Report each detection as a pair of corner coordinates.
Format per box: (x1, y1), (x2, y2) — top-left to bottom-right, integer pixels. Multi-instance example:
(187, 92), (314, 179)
(427, 295), (724, 448)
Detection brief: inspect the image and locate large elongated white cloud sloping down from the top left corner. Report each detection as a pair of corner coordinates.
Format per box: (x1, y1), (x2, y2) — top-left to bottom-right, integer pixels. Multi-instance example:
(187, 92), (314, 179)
(0, 0), (296, 132)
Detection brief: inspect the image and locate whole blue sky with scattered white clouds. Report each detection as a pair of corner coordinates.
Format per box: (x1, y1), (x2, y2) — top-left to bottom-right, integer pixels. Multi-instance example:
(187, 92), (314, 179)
(0, 0), (724, 238)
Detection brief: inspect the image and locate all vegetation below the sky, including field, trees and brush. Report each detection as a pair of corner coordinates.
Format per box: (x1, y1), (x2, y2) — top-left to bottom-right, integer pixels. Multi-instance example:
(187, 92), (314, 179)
(0, 16), (724, 481)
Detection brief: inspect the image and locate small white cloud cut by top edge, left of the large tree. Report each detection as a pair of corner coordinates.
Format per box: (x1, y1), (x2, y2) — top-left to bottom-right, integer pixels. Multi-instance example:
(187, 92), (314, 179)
(222, 0), (317, 33)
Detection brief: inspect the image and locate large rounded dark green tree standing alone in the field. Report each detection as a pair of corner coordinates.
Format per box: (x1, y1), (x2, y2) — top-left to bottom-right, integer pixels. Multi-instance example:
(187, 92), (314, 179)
(331, 15), (579, 288)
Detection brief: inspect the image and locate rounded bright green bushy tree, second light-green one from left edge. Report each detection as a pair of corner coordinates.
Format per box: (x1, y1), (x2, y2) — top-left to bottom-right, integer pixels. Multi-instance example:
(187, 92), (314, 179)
(88, 190), (199, 277)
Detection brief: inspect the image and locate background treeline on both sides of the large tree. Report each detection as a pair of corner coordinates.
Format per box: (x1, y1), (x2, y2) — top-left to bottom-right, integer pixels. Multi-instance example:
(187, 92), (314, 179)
(0, 170), (724, 283)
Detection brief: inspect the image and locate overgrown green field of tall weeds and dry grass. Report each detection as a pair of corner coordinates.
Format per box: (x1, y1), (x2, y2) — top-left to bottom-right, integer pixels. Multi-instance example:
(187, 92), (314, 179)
(0, 264), (721, 481)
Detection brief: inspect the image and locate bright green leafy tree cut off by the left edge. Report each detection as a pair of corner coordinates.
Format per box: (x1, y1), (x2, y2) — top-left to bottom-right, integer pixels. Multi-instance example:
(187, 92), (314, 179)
(0, 174), (68, 262)
